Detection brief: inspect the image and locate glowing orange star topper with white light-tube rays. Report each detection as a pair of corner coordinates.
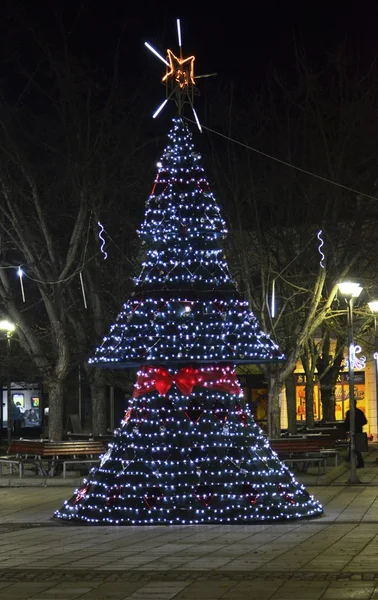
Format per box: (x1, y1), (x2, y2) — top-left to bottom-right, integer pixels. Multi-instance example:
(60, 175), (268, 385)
(145, 19), (215, 131)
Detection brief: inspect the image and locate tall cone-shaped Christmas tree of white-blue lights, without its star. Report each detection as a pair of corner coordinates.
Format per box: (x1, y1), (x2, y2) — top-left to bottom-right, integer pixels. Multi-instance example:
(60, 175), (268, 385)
(55, 117), (322, 525)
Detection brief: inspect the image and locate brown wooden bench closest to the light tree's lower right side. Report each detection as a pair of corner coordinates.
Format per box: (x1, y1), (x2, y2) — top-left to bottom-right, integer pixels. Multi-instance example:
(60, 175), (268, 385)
(269, 435), (338, 473)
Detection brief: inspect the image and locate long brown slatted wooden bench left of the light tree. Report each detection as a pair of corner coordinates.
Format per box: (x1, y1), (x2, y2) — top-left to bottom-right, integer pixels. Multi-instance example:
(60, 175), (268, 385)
(0, 439), (106, 478)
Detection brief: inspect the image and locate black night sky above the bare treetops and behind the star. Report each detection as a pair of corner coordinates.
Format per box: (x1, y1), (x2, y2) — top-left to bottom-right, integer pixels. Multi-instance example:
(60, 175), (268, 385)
(0, 0), (378, 123)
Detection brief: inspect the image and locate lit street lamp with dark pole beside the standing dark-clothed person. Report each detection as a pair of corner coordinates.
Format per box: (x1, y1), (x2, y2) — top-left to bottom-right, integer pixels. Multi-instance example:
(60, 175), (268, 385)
(337, 281), (362, 483)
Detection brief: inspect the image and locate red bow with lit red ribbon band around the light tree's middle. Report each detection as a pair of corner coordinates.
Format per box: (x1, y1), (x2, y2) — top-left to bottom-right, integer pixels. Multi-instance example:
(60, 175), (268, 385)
(133, 366), (241, 398)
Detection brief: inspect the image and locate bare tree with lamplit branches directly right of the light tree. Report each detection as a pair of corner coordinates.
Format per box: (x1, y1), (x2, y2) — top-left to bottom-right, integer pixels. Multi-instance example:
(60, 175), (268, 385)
(205, 43), (378, 437)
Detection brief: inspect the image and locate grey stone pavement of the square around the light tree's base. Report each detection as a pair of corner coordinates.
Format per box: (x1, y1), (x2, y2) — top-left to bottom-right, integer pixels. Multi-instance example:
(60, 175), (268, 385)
(0, 450), (378, 600)
